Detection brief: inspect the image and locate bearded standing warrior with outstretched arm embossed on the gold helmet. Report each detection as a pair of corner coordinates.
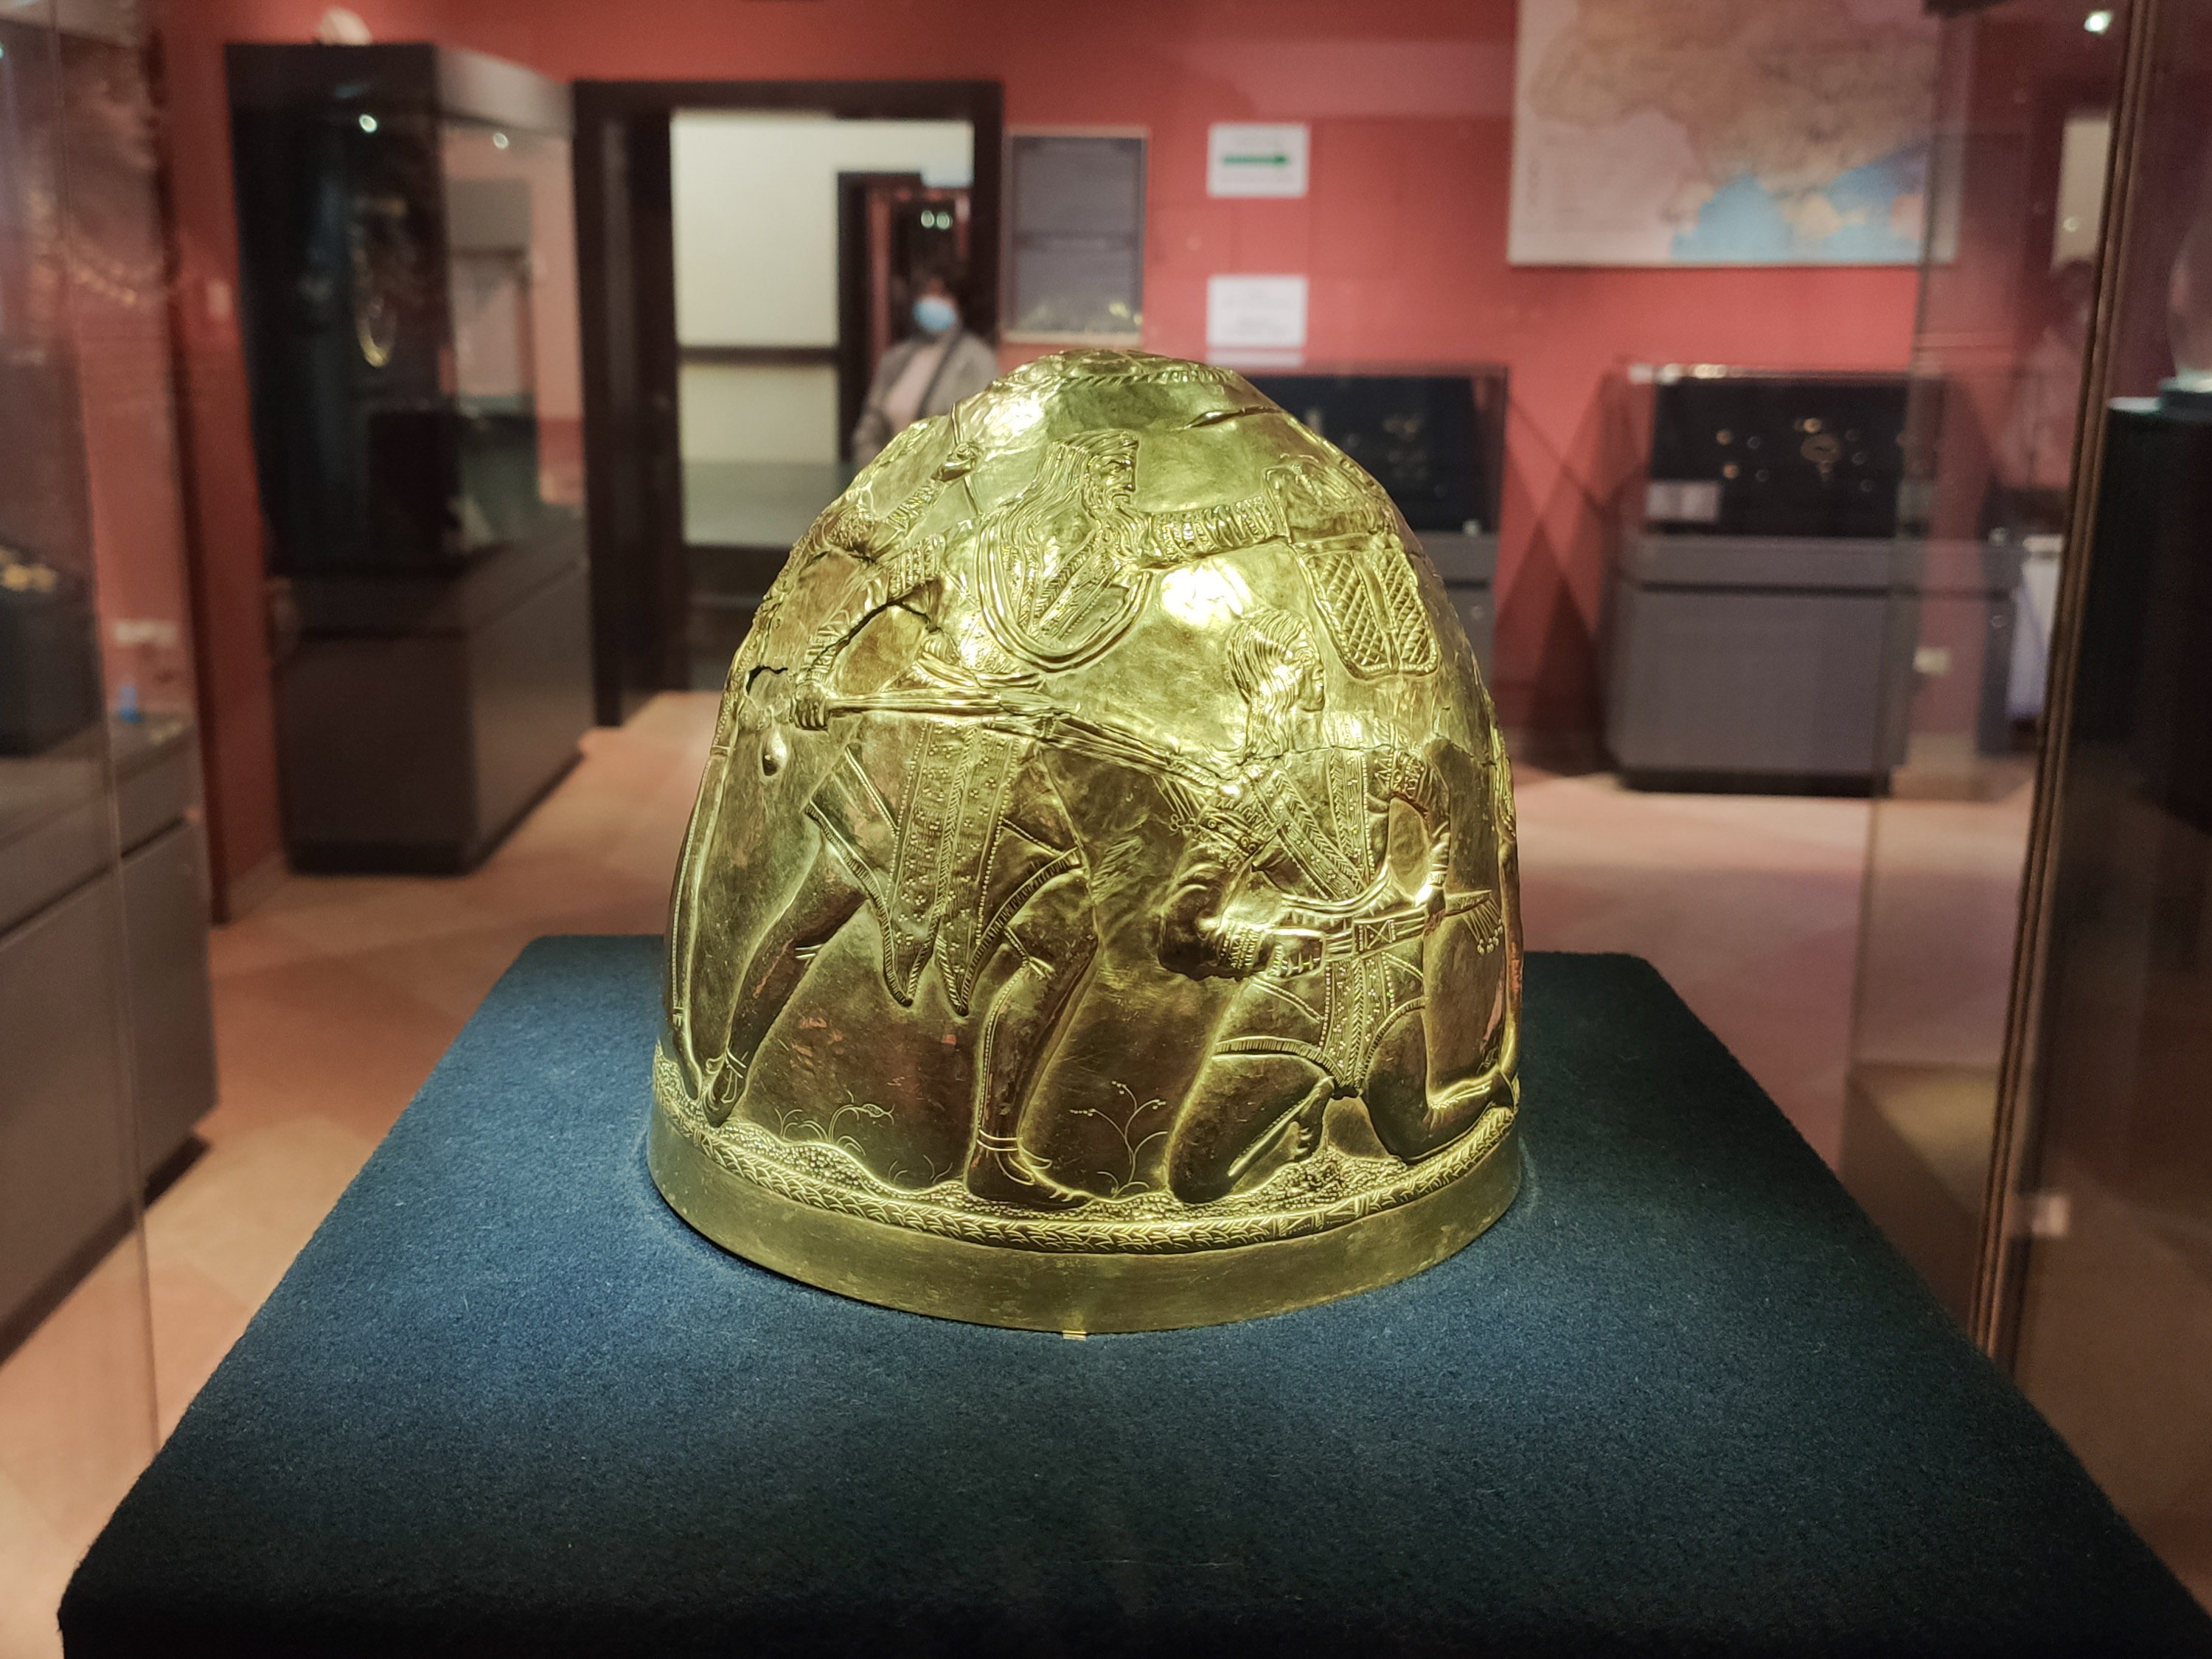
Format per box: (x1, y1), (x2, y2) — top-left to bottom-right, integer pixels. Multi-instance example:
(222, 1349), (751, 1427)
(672, 418), (1281, 1208)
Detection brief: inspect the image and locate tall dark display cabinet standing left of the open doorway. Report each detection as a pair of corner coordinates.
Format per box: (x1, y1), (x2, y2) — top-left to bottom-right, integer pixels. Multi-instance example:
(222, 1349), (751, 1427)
(226, 44), (591, 872)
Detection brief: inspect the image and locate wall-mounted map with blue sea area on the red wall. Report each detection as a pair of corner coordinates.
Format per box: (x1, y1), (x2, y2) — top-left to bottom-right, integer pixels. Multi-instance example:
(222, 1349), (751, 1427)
(1509, 0), (1935, 265)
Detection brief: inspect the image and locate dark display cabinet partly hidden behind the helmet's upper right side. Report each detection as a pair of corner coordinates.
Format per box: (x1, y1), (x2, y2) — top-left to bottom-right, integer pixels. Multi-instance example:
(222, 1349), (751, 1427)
(1252, 363), (1509, 672)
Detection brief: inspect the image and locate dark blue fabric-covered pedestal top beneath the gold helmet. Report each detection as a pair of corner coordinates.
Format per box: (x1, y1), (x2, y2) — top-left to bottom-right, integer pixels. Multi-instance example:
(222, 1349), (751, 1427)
(62, 938), (2212, 1659)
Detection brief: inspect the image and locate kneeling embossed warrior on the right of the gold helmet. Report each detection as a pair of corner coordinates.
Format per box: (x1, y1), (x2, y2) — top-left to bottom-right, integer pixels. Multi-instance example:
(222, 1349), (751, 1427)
(1159, 608), (1511, 1203)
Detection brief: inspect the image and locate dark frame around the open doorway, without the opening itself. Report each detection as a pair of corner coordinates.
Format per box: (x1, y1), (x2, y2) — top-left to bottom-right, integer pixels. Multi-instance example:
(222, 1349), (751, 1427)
(573, 80), (1006, 726)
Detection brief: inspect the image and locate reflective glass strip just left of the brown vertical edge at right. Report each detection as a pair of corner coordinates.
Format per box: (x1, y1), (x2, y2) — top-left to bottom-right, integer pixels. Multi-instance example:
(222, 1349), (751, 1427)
(1843, 0), (2121, 1321)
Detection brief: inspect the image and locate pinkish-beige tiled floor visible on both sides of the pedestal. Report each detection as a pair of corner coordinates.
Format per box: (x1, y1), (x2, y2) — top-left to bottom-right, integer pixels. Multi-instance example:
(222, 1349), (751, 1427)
(0, 697), (1973, 1659)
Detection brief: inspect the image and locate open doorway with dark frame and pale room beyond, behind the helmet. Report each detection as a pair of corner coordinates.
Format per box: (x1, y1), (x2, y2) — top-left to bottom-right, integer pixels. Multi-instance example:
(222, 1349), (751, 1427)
(575, 82), (1002, 723)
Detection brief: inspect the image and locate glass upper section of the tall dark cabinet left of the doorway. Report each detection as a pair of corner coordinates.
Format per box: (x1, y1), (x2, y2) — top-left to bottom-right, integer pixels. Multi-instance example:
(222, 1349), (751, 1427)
(232, 95), (584, 575)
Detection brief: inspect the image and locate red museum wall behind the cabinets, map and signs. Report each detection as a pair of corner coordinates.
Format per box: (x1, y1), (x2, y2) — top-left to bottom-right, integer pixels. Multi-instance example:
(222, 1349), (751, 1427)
(157, 0), (1916, 911)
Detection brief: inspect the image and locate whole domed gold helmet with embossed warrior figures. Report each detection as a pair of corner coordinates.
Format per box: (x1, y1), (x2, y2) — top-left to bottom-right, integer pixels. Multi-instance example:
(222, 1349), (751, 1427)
(648, 352), (1520, 1332)
